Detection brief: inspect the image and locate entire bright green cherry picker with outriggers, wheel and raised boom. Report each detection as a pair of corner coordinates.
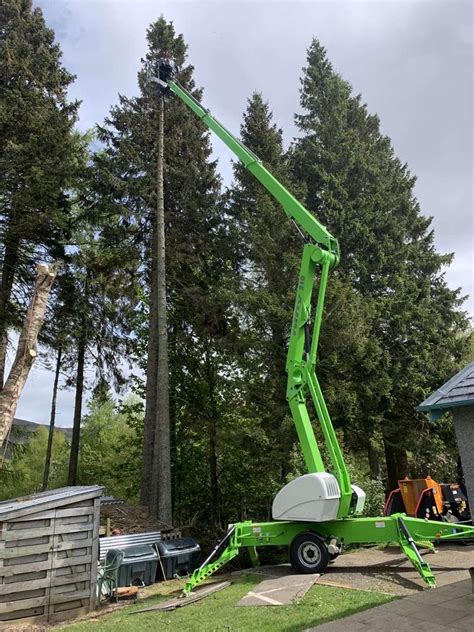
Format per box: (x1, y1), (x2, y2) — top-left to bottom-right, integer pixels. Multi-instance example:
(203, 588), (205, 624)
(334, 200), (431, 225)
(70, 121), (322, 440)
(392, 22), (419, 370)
(153, 59), (474, 594)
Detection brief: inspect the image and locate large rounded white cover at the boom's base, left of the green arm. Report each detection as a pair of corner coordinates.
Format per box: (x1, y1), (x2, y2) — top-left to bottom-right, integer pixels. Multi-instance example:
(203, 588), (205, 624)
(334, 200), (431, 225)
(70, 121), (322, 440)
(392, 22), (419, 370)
(272, 472), (341, 522)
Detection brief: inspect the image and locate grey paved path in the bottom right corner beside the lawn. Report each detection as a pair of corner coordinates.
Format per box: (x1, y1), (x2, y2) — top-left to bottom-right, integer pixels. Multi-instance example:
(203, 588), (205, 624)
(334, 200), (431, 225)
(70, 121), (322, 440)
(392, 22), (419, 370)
(306, 579), (474, 632)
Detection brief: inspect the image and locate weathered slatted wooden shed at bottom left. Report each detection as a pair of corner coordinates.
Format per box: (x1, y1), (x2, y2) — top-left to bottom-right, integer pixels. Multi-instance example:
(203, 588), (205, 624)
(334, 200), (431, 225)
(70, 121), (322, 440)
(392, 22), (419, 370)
(0, 486), (102, 628)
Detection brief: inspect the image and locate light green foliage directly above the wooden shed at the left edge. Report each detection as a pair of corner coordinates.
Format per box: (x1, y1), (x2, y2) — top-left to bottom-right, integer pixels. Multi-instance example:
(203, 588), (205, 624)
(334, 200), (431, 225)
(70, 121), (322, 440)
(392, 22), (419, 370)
(0, 428), (69, 500)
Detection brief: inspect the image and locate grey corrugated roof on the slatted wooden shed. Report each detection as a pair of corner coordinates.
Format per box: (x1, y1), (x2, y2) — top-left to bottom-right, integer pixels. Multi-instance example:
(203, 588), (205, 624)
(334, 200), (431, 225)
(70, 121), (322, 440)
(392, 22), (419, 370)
(0, 485), (103, 521)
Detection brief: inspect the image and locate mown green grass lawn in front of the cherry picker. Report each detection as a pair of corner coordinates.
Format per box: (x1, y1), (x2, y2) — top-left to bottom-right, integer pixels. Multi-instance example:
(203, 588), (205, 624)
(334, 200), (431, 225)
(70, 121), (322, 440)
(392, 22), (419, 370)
(61, 575), (392, 632)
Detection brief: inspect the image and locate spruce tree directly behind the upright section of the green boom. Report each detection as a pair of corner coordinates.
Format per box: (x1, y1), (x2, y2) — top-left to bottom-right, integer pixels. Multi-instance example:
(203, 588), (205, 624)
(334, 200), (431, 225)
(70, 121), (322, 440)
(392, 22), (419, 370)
(229, 94), (386, 485)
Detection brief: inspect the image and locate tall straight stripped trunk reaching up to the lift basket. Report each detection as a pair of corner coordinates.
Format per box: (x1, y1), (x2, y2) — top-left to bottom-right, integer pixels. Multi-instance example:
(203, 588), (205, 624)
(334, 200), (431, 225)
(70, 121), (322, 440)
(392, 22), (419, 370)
(149, 96), (172, 526)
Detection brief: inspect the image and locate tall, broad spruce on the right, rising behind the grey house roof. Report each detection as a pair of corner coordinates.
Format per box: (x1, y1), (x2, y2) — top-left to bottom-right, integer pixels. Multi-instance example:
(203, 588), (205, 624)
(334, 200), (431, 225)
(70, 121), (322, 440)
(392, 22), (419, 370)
(294, 40), (466, 487)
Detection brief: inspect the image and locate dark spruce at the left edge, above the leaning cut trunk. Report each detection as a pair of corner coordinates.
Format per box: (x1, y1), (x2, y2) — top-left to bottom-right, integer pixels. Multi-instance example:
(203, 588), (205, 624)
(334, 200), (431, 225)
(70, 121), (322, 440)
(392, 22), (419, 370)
(0, 0), (82, 388)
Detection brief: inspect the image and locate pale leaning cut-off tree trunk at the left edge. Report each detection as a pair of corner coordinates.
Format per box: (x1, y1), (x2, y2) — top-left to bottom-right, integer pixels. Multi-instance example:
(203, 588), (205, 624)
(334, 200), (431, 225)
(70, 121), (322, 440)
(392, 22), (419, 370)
(0, 263), (59, 445)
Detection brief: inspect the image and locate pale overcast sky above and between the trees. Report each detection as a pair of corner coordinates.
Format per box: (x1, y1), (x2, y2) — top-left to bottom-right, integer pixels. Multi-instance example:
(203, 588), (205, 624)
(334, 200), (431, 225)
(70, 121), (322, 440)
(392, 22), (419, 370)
(12, 0), (474, 426)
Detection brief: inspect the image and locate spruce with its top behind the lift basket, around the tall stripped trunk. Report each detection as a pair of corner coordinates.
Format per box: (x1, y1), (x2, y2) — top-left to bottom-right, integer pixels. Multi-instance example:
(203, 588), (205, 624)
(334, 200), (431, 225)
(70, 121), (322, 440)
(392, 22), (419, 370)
(99, 17), (222, 522)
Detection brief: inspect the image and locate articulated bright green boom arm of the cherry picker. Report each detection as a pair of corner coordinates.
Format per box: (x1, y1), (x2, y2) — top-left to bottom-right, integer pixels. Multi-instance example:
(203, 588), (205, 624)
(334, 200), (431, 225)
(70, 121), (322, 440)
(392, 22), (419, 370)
(165, 79), (352, 518)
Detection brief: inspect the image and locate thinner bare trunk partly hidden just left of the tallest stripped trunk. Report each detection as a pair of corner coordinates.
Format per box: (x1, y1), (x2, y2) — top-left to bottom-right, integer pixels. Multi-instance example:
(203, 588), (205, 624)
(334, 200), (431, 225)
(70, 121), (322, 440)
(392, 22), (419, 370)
(140, 214), (158, 505)
